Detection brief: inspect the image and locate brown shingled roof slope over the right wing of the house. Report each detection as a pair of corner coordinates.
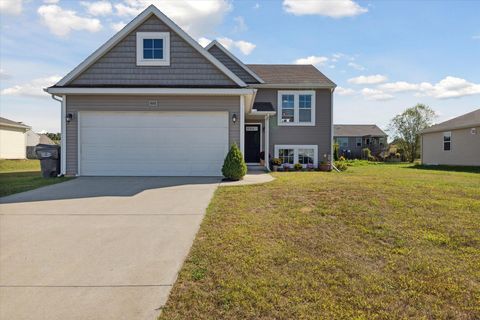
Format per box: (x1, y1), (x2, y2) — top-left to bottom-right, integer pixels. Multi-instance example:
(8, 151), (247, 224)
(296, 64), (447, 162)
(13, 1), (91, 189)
(247, 64), (337, 88)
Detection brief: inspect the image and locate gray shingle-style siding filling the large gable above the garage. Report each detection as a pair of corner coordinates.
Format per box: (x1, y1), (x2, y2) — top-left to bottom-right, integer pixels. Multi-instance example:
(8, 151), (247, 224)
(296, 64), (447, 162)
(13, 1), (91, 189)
(69, 16), (237, 87)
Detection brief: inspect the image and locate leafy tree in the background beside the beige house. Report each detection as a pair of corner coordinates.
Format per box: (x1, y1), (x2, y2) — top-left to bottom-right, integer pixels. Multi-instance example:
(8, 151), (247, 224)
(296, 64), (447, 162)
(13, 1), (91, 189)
(389, 103), (436, 162)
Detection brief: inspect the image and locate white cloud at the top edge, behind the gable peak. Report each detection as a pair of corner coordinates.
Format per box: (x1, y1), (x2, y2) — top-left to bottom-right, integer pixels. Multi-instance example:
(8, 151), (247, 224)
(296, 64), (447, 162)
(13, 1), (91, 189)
(115, 0), (232, 37)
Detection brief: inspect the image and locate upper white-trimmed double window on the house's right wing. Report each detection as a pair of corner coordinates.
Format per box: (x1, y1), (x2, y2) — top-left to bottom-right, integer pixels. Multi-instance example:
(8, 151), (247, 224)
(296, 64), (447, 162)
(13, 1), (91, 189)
(277, 90), (315, 126)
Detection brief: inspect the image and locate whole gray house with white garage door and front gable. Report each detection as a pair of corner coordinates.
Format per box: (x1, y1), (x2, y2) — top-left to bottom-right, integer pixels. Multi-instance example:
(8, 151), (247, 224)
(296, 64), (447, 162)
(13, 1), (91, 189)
(46, 5), (335, 176)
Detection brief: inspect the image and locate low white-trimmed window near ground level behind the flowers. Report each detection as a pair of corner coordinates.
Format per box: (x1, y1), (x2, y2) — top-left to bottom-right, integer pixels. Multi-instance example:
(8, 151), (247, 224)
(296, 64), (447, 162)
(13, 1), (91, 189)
(274, 144), (318, 168)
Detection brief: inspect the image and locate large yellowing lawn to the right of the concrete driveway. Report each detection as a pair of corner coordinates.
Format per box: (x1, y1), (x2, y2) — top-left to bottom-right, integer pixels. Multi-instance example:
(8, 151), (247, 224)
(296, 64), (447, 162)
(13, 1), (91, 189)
(160, 164), (480, 319)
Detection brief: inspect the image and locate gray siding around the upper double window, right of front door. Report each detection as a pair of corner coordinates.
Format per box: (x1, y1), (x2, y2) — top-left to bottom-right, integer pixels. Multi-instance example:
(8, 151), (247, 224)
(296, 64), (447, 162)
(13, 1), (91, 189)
(255, 89), (332, 162)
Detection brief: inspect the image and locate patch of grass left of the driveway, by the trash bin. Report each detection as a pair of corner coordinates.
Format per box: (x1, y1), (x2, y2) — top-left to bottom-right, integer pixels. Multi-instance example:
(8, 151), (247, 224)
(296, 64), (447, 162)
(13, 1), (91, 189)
(0, 160), (69, 197)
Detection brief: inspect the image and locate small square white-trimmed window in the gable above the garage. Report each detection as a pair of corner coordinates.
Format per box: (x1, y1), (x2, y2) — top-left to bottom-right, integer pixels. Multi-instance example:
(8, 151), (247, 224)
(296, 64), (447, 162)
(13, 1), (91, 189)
(137, 32), (170, 66)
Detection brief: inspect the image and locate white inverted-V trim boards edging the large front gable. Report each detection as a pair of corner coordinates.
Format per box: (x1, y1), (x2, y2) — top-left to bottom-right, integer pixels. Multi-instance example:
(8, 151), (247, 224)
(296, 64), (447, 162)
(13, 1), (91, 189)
(55, 5), (247, 87)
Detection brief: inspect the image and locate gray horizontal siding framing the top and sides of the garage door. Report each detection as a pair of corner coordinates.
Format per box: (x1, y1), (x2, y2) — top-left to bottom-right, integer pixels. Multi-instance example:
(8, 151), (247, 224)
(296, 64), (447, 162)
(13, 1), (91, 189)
(66, 95), (240, 175)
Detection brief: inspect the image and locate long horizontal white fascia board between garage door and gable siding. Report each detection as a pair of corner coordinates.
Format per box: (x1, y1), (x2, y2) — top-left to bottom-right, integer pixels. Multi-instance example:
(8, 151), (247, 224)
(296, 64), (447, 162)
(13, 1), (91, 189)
(45, 87), (256, 96)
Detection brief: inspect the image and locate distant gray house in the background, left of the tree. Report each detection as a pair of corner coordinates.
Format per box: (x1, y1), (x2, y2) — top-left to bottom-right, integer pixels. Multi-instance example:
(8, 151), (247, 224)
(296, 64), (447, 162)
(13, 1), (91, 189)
(333, 124), (388, 158)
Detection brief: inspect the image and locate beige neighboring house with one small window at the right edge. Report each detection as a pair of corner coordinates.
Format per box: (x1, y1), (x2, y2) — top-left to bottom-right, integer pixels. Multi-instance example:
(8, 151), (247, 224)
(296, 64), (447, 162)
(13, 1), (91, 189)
(421, 109), (480, 166)
